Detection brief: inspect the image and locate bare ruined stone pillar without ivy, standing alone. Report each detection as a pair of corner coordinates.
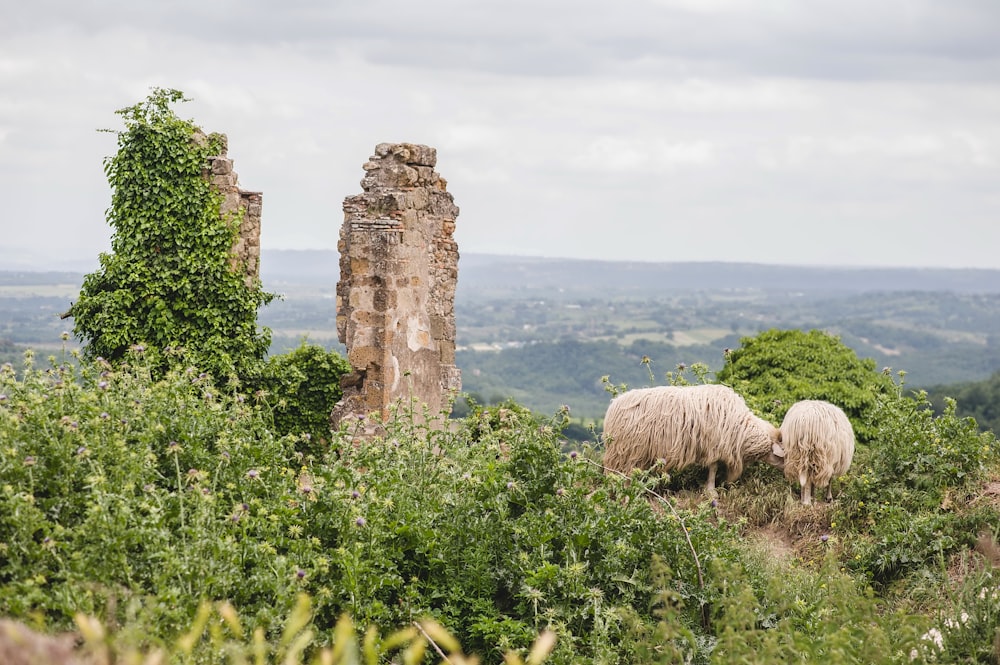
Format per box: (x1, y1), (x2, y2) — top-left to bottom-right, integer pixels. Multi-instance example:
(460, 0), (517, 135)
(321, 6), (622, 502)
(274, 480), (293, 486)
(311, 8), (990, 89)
(331, 143), (462, 428)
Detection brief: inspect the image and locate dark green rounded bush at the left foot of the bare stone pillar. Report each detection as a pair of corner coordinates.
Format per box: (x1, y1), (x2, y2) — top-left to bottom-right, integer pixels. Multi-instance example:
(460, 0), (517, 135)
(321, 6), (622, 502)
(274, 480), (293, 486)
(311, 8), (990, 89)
(251, 341), (351, 450)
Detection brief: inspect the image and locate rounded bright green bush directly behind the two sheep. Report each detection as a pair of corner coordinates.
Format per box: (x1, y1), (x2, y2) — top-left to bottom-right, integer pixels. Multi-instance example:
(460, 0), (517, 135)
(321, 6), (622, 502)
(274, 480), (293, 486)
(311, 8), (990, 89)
(717, 329), (893, 442)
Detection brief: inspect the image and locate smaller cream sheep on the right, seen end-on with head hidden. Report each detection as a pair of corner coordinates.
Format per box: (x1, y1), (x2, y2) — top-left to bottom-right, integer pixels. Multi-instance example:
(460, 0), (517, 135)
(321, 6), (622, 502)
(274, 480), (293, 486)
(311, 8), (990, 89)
(781, 400), (854, 506)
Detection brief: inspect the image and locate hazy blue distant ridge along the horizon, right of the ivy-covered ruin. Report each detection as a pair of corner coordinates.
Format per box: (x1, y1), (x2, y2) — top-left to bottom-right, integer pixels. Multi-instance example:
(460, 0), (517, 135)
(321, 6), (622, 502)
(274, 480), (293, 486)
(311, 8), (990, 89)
(261, 250), (1000, 295)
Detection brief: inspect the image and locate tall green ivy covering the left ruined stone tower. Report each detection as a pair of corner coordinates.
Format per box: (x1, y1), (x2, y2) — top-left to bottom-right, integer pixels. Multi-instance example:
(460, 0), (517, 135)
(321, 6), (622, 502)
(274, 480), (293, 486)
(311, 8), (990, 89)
(70, 88), (272, 378)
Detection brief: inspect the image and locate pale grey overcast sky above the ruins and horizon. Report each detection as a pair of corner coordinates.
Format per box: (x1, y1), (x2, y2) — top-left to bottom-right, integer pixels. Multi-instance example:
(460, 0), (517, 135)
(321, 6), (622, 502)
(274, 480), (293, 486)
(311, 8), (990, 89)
(0, 0), (1000, 269)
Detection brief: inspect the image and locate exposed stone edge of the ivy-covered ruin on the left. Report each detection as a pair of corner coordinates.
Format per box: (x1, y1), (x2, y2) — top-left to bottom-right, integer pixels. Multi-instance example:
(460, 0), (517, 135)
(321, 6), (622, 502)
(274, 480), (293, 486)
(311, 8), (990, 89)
(195, 134), (263, 287)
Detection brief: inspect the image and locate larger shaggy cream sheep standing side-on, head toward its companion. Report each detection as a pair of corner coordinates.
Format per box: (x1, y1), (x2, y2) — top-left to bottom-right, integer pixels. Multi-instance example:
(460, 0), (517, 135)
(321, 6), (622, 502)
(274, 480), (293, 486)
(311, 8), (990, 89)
(604, 384), (785, 492)
